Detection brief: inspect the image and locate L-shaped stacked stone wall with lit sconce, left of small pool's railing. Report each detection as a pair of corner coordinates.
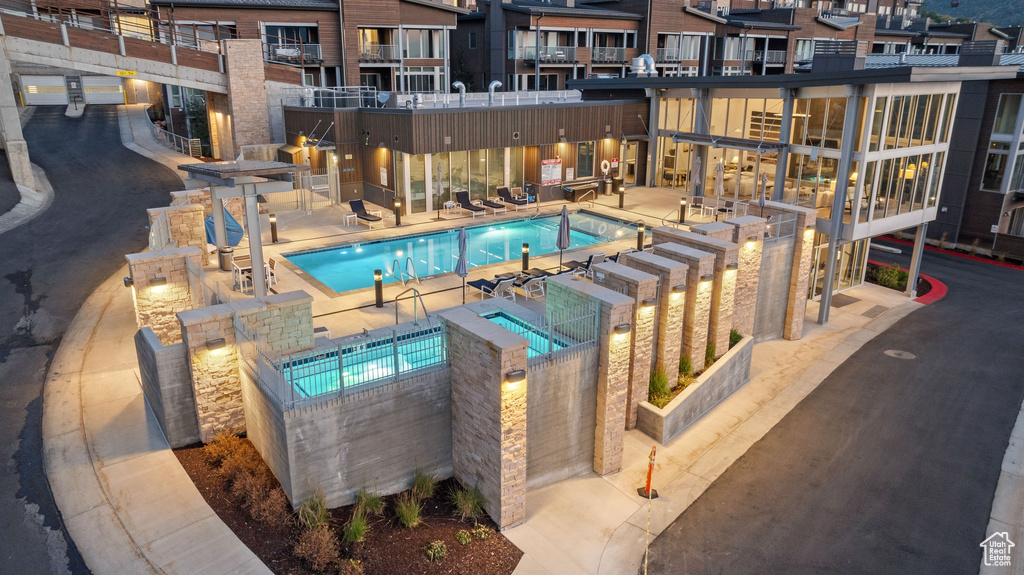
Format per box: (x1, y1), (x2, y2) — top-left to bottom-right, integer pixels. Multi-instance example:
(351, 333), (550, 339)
(177, 292), (313, 442)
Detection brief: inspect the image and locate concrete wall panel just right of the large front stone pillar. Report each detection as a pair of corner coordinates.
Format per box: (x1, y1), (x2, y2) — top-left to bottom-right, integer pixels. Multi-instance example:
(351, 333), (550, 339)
(526, 347), (597, 489)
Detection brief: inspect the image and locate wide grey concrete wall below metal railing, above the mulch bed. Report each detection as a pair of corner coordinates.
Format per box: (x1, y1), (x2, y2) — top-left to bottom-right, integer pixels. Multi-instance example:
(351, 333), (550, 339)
(272, 368), (452, 507)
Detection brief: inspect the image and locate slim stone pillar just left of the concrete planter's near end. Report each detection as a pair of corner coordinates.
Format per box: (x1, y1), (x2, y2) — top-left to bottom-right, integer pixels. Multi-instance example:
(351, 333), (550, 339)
(594, 262), (658, 430)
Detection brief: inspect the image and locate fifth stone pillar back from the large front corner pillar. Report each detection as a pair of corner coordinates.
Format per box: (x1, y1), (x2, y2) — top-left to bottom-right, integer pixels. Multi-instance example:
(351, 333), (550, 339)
(654, 244), (715, 372)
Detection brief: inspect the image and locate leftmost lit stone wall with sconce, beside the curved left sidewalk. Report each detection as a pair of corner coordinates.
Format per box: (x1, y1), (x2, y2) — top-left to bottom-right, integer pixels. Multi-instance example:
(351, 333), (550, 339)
(125, 247), (203, 346)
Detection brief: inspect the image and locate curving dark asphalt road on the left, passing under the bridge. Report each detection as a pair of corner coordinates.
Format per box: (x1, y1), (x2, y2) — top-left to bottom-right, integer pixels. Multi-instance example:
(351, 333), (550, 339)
(0, 105), (181, 575)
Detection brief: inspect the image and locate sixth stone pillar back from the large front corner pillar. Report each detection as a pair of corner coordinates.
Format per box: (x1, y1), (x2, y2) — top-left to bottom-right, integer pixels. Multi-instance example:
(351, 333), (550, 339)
(653, 224), (739, 358)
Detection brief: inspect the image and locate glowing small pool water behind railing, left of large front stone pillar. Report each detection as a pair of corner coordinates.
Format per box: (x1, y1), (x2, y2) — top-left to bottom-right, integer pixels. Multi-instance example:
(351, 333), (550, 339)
(281, 325), (445, 397)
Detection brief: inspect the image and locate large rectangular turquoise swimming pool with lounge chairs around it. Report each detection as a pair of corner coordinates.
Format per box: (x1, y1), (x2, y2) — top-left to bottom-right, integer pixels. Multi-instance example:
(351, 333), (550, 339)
(284, 212), (636, 292)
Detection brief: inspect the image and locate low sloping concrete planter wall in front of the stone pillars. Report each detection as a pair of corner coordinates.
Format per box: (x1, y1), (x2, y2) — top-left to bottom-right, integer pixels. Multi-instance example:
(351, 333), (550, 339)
(637, 338), (754, 444)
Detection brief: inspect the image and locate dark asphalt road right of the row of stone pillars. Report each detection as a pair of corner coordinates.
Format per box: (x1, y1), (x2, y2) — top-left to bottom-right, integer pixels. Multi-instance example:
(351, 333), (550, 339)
(649, 239), (1024, 574)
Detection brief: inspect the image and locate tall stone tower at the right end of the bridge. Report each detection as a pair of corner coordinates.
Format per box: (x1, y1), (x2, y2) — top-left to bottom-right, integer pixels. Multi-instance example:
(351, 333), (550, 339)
(221, 40), (270, 153)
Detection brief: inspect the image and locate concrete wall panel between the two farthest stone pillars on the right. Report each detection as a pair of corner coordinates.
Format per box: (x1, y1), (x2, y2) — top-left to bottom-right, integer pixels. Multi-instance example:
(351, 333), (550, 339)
(754, 236), (796, 343)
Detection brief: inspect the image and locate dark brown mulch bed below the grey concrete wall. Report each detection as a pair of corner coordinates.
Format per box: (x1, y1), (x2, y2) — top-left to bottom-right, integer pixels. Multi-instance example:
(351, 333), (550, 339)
(174, 445), (522, 575)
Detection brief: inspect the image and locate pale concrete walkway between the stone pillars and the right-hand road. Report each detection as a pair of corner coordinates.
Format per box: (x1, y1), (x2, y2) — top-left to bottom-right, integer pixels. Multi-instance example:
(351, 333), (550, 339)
(504, 284), (921, 575)
